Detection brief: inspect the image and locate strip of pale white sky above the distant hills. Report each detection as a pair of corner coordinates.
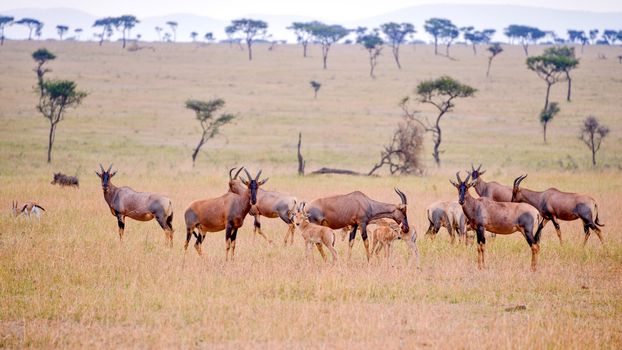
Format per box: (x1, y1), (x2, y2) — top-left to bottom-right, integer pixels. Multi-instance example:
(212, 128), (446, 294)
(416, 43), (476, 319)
(0, 0), (622, 21)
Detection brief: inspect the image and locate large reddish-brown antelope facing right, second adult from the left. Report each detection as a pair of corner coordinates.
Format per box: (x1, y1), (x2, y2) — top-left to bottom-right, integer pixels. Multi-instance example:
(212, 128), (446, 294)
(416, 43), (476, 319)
(184, 167), (268, 260)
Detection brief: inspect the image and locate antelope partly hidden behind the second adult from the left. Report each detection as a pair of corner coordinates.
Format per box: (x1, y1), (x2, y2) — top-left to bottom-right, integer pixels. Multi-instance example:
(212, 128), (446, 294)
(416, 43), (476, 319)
(229, 178), (298, 245)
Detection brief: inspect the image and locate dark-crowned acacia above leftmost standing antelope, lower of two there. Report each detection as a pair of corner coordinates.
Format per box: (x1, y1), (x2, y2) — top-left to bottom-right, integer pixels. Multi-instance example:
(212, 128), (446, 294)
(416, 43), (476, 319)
(37, 80), (86, 163)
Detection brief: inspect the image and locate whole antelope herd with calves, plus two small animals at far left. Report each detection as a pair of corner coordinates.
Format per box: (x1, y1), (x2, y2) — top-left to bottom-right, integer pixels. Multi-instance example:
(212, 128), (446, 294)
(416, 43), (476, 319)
(11, 164), (604, 271)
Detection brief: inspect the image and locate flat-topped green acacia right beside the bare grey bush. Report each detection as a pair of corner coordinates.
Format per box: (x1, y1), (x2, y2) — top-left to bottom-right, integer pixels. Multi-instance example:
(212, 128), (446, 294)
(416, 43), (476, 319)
(400, 76), (477, 167)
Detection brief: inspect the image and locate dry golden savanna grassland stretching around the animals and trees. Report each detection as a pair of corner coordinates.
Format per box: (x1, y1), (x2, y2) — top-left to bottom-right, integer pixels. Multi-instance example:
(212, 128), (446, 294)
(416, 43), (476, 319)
(0, 41), (622, 349)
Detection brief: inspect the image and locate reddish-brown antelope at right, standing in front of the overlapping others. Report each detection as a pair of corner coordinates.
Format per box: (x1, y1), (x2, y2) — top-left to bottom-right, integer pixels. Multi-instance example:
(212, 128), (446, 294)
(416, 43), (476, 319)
(449, 172), (541, 271)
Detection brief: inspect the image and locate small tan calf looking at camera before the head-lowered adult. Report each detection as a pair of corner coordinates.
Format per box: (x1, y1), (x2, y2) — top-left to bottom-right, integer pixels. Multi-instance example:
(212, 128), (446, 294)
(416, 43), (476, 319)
(294, 202), (337, 264)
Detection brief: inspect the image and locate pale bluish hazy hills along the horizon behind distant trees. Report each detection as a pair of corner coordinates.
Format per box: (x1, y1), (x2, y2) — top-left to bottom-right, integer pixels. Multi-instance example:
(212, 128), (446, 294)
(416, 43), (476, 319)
(0, 4), (622, 42)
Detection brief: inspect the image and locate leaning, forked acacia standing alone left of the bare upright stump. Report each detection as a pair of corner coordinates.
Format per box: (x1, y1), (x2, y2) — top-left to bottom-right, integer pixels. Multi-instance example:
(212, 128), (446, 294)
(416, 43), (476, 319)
(186, 98), (235, 167)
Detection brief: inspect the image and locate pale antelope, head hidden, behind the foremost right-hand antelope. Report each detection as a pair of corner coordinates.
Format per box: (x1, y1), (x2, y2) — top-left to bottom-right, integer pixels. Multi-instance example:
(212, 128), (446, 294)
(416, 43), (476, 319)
(425, 201), (469, 244)
